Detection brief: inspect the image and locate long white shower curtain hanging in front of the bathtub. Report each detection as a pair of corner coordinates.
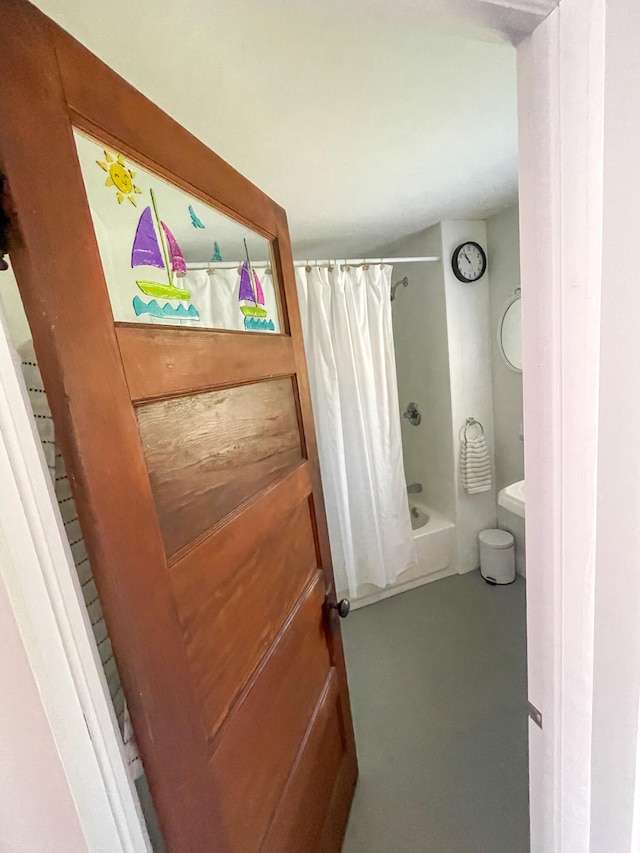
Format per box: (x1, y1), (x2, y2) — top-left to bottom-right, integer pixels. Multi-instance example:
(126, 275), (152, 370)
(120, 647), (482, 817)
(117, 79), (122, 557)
(296, 264), (415, 596)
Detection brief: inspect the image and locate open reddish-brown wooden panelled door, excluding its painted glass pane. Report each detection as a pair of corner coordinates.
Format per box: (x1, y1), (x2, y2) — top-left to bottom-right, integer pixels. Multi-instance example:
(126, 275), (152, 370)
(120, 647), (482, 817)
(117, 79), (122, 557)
(0, 0), (357, 853)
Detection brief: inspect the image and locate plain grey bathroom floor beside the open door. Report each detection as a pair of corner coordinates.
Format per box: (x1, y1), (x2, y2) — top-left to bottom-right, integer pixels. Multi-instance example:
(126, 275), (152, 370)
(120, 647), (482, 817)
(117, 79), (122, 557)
(342, 572), (529, 853)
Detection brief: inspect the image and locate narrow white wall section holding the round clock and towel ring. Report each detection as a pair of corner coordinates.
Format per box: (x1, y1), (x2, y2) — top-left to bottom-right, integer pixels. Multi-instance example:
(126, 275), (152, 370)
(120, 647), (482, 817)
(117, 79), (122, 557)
(441, 220), (497, 573)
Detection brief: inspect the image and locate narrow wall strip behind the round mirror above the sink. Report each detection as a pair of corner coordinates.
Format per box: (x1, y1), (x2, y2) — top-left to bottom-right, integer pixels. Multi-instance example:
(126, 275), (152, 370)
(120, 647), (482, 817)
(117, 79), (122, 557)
(487, 205), (524, 491)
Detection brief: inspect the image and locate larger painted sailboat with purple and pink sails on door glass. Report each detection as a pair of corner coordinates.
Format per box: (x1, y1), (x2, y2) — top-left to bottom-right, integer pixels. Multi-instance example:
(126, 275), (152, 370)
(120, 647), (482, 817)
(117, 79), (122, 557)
(131, 190), (200, 312)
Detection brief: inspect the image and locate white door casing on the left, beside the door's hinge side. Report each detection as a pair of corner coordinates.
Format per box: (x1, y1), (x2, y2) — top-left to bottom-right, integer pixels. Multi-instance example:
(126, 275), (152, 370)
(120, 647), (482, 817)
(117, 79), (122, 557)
(0, 290), (149, 853)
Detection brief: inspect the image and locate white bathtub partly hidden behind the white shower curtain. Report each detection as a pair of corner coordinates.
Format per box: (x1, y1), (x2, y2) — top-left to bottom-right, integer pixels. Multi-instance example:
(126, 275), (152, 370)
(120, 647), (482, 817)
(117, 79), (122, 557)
(344, 495), (457, 610)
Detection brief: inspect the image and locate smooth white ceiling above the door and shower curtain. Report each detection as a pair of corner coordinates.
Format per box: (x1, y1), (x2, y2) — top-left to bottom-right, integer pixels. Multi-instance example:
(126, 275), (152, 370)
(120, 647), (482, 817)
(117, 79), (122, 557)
(32, 0), (556, 257)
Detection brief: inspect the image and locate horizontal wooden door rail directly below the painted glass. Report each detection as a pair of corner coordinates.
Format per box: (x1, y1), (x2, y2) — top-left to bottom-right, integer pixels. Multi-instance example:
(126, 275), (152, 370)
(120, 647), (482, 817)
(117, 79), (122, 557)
(116, 323), (295, 403)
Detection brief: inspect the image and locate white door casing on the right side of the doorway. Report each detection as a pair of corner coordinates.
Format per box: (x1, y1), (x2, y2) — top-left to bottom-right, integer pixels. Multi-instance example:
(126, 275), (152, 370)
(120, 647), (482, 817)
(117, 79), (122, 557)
(518, 0), (605, 853)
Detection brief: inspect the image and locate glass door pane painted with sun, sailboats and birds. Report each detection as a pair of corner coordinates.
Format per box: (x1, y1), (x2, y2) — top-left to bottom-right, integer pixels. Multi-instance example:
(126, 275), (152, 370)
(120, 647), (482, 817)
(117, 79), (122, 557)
(74, 131), (280, 332)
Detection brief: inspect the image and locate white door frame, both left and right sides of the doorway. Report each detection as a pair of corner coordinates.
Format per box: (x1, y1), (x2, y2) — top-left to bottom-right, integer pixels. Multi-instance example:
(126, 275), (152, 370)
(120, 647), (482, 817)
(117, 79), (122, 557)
(0, 0), (620, 853)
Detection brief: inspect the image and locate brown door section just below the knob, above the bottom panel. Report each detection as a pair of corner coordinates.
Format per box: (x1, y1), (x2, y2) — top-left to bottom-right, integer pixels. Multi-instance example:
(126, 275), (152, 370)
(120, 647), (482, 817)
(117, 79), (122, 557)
(210, 572), (337, 853)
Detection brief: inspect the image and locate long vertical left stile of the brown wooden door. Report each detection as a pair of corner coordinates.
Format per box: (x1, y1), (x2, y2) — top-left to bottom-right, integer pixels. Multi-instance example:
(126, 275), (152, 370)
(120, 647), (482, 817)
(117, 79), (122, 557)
(0, 5), (217, 850)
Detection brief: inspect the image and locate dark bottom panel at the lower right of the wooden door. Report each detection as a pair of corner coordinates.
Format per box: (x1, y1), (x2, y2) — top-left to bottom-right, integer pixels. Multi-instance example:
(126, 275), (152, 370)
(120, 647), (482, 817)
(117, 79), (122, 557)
(261, 669), (345, 853)
